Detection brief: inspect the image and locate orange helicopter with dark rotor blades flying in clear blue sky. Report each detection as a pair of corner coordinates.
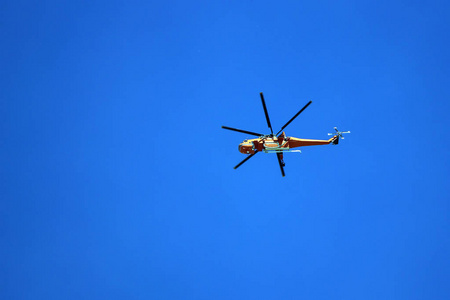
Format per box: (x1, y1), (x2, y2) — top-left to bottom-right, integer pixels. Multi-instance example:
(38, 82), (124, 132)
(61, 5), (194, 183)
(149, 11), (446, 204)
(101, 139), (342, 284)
(222, 93), (350, 177)
